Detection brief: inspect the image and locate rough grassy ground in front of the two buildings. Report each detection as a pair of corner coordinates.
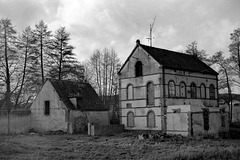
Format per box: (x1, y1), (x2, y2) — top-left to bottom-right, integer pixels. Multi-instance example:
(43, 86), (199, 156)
(0, 133), (240, 160)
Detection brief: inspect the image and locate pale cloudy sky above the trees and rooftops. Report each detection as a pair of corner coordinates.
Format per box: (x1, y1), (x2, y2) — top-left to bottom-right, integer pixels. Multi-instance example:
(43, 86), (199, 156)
(0, 0), (240, 61)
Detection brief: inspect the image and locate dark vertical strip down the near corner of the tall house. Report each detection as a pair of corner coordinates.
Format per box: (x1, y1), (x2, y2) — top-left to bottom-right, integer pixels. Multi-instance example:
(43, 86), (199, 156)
(161, 67), (167, 133)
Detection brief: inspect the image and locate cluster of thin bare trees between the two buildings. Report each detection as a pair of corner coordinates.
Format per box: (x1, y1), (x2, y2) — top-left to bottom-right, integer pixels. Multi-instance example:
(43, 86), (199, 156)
(89, 48), (120, 104)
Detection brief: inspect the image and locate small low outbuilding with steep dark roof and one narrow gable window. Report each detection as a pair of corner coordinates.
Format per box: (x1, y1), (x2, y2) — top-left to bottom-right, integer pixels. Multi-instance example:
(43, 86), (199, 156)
(30, 79), (109, 133)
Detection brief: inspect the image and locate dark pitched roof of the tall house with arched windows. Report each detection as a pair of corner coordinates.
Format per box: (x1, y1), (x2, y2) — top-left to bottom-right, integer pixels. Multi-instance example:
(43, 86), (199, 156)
(119, 40), (218, 75)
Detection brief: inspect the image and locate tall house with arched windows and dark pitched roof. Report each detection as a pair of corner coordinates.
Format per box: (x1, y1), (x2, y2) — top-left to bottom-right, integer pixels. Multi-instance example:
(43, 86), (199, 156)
(119, 40), (223, 134)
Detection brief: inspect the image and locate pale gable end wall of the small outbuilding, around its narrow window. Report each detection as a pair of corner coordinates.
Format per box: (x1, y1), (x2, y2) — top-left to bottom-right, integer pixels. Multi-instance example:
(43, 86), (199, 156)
(31, 81), (68, 131)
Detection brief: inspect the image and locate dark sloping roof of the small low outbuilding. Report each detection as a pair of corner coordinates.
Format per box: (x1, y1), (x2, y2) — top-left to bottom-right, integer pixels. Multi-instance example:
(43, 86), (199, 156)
(49, 79), (108, 111)
